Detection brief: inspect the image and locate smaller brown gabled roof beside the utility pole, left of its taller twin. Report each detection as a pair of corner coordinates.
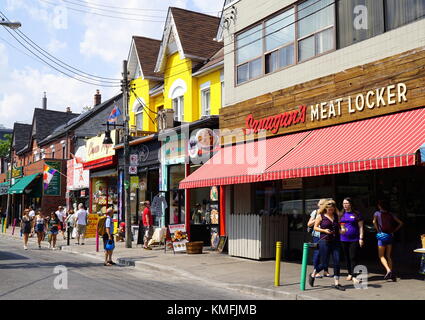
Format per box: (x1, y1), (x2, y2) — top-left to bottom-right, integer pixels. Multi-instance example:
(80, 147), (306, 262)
(129, 36), (163, 79)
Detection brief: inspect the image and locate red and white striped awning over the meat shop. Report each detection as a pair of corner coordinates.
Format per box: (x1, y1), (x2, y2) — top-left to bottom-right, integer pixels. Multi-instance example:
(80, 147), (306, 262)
(180, 108), (425, 189)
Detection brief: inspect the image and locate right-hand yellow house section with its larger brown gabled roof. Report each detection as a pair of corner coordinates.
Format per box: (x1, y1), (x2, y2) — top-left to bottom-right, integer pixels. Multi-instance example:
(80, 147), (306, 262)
(155, 7), (223, 122)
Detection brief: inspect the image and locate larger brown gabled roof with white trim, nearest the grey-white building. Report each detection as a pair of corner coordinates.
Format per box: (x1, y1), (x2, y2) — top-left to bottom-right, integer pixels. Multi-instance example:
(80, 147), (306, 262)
(155, 7), (223, 72)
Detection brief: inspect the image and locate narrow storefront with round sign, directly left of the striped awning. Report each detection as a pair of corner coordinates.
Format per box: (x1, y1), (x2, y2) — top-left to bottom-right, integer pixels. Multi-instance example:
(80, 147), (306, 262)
(160, 116), (218, 236)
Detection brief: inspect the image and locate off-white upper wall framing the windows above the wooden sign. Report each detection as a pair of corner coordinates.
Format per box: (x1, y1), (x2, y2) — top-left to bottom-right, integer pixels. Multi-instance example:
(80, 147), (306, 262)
(224, 0), (425, 106)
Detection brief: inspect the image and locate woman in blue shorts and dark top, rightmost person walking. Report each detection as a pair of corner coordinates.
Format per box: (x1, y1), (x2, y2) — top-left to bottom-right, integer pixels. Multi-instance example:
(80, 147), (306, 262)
(373, 200), (403, 281)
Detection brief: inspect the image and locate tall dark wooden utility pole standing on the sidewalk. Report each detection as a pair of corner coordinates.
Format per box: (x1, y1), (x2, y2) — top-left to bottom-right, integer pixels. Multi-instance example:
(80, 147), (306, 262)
(122, 60), (132, 248)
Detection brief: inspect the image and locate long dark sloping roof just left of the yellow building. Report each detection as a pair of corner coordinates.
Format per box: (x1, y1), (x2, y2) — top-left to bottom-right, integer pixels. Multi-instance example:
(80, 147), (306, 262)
(38, 93), (123, 146)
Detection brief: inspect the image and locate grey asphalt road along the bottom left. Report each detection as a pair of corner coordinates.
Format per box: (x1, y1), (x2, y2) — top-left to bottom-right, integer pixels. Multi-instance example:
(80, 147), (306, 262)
(0, 238), (258, 301)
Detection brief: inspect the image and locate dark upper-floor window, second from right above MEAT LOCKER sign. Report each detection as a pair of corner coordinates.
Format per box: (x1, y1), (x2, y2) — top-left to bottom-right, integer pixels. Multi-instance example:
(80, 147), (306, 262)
(337, 0), (384, 48)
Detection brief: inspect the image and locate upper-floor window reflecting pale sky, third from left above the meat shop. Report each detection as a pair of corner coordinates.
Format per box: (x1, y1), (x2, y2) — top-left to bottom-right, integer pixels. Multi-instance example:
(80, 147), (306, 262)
(298, 0), (335, 61)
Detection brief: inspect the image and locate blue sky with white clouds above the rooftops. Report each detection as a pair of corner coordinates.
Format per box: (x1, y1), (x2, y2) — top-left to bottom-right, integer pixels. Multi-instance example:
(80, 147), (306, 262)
(0, 0), (223, 128)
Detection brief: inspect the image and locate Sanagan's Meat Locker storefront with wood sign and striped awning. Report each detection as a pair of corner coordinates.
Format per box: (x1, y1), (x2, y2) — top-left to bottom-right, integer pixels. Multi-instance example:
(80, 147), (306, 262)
(180, 47), (425, 267)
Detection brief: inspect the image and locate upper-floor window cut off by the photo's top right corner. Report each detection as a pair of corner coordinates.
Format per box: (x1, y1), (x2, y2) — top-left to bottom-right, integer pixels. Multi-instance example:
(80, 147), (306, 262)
(385, 0), (425, 30)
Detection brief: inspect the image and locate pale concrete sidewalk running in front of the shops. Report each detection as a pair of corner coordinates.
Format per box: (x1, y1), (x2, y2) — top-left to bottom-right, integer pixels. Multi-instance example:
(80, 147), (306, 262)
(0, 228), (425, 300)
